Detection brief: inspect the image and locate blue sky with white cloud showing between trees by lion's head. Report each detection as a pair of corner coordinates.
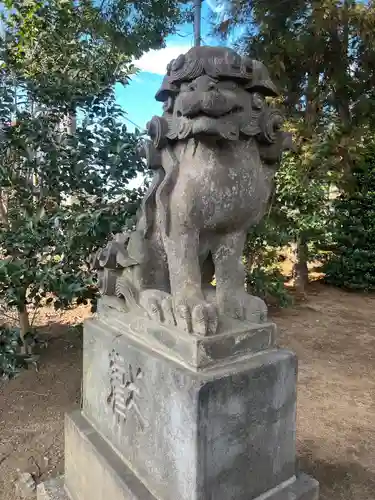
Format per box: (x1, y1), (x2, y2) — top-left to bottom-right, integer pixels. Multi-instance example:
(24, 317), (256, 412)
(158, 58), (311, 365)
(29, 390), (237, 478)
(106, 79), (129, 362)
(116, 0), (234, 131)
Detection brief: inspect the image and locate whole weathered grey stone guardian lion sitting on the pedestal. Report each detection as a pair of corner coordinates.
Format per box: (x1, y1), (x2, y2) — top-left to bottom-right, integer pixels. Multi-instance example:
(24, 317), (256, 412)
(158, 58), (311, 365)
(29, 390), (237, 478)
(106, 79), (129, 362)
(95, 47), (291, 335)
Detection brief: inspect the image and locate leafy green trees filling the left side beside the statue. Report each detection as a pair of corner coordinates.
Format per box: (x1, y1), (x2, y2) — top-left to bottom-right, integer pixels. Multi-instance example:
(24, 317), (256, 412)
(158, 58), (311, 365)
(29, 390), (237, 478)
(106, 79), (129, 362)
(0, 0), (187, 373)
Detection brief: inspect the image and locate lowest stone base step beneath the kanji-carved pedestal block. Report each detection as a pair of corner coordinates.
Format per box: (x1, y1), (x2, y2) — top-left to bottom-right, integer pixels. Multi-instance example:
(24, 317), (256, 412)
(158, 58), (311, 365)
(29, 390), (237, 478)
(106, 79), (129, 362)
(63, 412), (318, 500)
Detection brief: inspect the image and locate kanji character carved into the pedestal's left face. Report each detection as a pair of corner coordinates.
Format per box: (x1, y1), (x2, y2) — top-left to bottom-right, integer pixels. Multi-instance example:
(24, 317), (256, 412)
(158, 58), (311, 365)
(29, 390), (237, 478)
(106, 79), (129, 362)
(107, 350), (146, 430)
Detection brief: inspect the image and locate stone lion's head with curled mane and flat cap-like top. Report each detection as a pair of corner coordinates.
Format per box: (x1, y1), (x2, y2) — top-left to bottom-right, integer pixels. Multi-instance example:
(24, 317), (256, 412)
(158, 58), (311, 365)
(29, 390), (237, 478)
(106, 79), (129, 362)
(147, 47), (290, 163)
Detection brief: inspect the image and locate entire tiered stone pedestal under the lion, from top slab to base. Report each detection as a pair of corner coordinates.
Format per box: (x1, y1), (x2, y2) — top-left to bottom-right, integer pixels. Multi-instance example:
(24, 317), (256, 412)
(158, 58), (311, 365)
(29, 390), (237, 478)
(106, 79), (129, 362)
(38, 304), (318, 500)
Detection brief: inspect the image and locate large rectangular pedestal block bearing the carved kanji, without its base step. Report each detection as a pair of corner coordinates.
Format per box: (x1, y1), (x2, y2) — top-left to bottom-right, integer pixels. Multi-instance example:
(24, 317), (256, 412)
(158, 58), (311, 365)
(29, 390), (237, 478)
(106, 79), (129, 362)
(83, 320), (296, 500)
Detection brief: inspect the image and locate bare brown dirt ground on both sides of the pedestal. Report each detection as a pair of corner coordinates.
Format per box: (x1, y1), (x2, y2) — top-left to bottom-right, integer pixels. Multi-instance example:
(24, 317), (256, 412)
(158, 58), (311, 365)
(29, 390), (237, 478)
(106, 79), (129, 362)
(0, 284), (375, 500)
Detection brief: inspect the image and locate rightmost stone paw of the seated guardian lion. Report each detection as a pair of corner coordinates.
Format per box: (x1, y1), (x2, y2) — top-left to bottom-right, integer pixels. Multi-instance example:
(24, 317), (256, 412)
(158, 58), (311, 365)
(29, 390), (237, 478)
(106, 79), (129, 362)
(218, 290), (267, 323)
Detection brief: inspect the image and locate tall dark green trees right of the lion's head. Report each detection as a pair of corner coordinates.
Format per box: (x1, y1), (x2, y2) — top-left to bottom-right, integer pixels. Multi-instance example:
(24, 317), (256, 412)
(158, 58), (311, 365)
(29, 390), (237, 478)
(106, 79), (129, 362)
(213, 0), (375, 291)
